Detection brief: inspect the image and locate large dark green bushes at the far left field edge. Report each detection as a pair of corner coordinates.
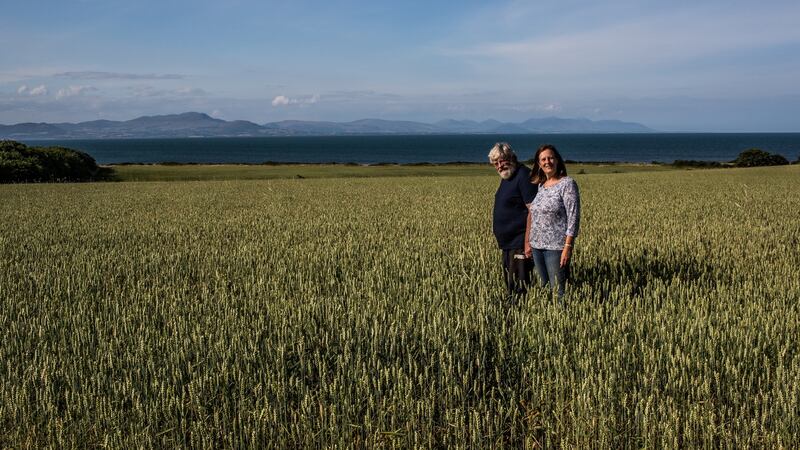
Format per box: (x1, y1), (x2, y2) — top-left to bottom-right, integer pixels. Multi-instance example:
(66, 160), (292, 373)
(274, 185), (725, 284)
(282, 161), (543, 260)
(0, 141), (107, 183)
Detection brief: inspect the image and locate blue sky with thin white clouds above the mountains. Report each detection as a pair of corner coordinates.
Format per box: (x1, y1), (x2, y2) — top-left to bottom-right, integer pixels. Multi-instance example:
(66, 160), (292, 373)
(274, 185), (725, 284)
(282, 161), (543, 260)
(0, 0), (800, 132)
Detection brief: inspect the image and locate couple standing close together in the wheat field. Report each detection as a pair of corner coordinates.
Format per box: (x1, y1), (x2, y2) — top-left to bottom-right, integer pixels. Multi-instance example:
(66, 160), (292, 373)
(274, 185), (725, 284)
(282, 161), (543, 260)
(489, 142), (580, 303)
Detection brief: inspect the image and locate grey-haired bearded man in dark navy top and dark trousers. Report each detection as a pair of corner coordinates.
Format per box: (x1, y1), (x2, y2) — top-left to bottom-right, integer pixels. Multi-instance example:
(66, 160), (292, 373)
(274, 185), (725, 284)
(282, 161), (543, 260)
(489, 142), (537, 303)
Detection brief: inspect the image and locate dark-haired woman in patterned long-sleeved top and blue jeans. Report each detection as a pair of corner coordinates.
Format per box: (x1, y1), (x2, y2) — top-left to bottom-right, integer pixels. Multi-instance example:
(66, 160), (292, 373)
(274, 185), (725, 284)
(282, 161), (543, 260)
(525, 144), (581, 297)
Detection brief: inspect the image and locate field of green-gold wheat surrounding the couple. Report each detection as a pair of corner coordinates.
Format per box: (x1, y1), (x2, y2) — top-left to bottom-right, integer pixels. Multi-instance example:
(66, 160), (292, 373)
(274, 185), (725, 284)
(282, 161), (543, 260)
(0, 167), (800, 448)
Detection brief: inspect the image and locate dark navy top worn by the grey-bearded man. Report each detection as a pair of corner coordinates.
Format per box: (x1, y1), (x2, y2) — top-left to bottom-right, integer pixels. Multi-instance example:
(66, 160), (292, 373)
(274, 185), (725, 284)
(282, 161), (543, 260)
(492, 164), (537, 250)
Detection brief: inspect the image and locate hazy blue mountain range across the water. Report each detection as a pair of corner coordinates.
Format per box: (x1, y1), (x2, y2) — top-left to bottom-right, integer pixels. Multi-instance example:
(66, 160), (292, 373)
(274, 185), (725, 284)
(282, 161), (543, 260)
(0, 112), (654, 139)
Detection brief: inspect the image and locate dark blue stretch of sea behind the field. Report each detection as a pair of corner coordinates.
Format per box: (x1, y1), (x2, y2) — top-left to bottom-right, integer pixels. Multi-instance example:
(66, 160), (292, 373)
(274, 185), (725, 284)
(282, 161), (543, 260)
(25, 133), (800, 164)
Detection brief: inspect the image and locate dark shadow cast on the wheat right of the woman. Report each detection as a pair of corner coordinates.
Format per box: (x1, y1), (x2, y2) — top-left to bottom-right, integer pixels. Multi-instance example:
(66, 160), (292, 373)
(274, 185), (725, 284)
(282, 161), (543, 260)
(570, 251), (726, 299)
